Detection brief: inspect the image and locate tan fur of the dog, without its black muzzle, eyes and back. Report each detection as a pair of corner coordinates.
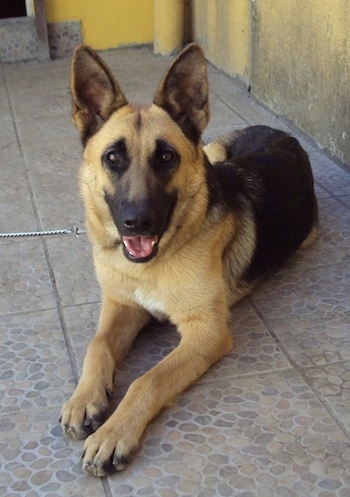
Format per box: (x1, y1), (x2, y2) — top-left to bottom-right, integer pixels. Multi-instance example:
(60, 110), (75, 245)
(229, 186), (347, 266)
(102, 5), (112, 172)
(62, 46), (318, 476)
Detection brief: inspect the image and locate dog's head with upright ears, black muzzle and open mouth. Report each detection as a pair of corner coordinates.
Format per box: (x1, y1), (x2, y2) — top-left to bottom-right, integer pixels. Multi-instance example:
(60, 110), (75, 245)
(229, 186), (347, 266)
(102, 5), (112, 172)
(71, 44), (209, 262)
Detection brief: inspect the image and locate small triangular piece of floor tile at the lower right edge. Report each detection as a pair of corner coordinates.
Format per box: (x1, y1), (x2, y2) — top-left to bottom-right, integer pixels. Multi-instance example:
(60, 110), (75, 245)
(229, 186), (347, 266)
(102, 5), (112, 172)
(305, 358), (350, 437)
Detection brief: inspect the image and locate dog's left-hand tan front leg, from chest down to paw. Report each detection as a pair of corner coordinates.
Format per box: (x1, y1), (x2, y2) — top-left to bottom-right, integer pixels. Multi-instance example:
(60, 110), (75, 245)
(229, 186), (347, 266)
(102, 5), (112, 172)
(61, 298), (149, 439)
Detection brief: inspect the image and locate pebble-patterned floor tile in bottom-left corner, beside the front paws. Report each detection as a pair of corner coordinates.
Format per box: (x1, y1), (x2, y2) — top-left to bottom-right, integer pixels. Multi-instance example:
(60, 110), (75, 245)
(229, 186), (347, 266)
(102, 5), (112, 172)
(0, 409), (104, 497)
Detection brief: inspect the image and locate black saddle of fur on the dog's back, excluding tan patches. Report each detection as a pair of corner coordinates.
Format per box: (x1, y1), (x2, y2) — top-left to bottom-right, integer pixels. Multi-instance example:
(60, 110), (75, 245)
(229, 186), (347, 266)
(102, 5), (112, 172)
(207, 126), (317, 282)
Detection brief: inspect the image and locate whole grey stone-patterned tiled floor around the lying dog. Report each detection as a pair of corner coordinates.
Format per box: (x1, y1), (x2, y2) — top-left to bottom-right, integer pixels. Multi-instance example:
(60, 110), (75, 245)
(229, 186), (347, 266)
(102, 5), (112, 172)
(0, 48), (350, 497)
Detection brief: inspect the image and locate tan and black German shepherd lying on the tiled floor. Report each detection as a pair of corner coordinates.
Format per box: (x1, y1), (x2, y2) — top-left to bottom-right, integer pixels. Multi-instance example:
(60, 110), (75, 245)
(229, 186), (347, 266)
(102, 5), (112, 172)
(61, 44), (317, 476)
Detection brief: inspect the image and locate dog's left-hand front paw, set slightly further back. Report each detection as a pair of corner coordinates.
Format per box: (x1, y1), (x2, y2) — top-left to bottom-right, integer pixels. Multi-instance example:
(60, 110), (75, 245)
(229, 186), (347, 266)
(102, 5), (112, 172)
(60, 387), (112, 440)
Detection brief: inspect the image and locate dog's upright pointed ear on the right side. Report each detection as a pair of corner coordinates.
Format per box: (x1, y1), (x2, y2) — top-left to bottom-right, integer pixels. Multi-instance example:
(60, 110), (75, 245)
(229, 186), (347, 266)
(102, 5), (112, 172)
(153, 43), (209, 144)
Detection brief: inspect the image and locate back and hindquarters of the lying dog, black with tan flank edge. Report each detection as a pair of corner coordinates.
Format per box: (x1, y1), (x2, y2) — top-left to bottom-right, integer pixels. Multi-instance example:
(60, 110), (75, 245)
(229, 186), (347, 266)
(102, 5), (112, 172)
(204, 126), (318, 300)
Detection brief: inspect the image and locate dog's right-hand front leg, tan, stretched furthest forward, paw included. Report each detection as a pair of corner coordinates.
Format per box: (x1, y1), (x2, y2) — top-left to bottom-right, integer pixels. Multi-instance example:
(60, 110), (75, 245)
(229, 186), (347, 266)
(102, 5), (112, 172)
(83, 312), (232, 476)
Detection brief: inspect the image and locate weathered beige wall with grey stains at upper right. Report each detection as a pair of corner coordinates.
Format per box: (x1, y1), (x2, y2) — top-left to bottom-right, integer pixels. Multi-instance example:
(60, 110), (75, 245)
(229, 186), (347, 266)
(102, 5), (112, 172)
(192, 0), (350, 163)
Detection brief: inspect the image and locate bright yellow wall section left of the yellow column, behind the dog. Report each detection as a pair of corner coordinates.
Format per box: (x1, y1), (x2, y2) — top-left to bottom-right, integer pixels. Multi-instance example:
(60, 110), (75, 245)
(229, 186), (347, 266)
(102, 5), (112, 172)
(45, 0), (153, 49)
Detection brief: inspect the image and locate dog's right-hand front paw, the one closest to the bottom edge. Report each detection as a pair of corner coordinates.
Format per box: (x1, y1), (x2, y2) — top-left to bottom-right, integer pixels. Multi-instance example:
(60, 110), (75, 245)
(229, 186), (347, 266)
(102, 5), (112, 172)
(82, 423), (139, 476)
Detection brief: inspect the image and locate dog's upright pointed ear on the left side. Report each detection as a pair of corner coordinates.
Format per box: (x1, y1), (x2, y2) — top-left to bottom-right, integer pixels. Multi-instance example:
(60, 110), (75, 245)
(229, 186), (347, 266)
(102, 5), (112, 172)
(71, 45), (128, 145)
